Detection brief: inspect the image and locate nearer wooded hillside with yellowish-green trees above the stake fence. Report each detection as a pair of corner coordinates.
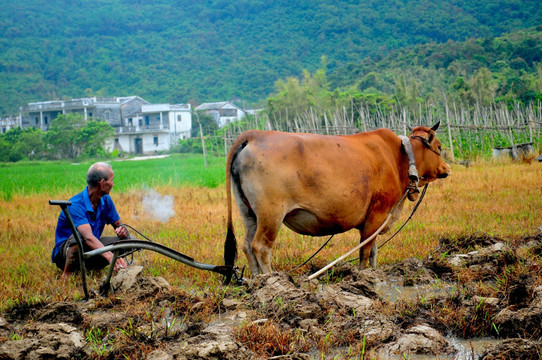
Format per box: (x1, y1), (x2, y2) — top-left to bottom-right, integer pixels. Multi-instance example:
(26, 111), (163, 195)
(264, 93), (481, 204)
(266, 26), (542, 122)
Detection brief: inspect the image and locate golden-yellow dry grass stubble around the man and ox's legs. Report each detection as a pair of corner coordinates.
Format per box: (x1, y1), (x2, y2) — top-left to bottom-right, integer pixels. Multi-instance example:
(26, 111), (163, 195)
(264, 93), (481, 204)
(0, 163), (542, 308)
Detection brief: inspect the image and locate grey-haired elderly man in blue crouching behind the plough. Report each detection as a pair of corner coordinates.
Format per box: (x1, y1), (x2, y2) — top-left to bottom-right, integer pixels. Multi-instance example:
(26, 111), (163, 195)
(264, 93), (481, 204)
(52, 162), (129, 278)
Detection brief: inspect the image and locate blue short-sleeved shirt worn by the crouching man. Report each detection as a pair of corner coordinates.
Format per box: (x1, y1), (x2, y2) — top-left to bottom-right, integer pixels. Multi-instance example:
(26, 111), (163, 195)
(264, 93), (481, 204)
(51, 187), (120, 262)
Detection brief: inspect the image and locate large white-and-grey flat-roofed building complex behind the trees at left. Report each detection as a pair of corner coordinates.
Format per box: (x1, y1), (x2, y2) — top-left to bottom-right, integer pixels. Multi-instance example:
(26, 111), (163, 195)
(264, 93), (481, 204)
(19, 96), (192, 155)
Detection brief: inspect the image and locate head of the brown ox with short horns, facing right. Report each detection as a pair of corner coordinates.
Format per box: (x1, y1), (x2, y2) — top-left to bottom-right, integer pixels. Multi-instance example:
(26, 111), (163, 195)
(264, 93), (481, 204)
(409, 121), (452, 186)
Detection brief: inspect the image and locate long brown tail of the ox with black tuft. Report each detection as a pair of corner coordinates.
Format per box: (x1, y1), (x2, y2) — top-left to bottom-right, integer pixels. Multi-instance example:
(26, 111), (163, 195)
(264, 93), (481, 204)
(224, 132), (255, 285)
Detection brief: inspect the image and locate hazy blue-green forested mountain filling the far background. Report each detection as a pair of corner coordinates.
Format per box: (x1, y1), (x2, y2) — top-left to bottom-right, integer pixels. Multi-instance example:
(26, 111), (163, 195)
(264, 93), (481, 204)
(0, 0), (542, 114)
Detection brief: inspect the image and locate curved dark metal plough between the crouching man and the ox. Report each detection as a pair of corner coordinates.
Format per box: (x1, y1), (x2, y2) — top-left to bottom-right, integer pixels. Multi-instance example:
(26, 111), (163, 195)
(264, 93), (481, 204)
(49, 200), (243, 300)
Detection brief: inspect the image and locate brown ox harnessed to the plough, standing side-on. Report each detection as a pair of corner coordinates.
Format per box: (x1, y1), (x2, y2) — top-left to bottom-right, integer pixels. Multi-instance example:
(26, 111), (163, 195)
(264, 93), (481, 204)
(224, 122), (451, 281)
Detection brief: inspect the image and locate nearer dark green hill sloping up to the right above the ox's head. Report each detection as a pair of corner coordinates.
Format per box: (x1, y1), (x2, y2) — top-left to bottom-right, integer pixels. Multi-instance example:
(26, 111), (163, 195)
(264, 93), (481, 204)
(329, 26), (542, 103)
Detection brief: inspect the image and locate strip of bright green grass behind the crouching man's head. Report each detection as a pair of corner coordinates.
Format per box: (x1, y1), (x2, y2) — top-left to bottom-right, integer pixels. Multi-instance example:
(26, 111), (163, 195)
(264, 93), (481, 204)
(0, 154), (225, 201)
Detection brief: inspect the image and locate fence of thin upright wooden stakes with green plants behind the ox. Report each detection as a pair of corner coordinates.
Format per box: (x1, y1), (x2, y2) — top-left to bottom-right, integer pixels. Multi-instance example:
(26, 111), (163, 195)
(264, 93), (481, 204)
(185, 103), (542, 160)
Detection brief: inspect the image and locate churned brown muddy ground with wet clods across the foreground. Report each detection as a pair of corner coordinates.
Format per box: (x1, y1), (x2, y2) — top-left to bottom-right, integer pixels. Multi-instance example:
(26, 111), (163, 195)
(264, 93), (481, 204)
(0, 234), (542, 360)
